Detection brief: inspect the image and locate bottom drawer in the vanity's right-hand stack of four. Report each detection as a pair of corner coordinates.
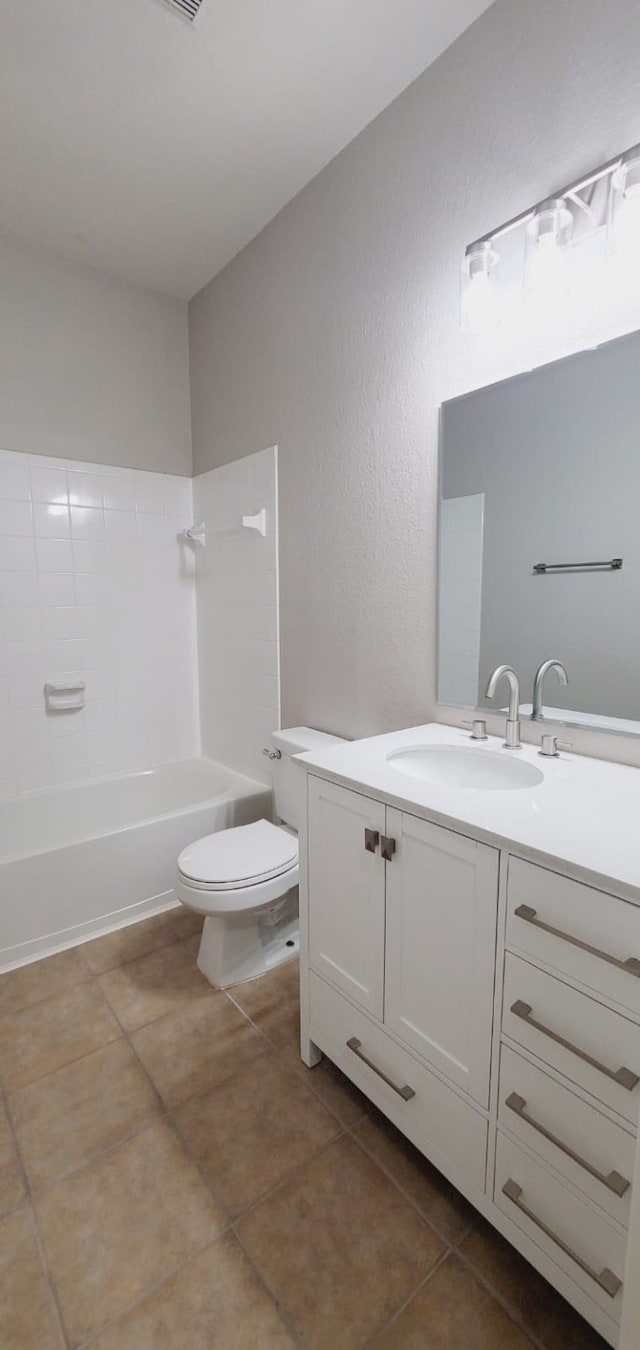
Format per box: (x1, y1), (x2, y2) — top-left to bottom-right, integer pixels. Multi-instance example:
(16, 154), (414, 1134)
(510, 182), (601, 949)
(494, 1133), (626, 1322)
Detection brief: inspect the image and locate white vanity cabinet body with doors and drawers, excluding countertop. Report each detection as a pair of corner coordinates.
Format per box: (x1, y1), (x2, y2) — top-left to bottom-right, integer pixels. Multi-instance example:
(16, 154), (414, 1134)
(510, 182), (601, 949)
(301, 765), (640, 1350)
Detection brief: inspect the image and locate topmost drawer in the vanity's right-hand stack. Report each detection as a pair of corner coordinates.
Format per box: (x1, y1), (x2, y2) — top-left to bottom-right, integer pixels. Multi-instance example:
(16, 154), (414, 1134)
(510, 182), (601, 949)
(506, 857), (640, 1017)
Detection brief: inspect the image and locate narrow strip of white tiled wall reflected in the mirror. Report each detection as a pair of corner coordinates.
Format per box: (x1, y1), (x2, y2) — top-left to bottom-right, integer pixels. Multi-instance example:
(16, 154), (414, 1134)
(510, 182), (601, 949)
(437, 493), (485, 707)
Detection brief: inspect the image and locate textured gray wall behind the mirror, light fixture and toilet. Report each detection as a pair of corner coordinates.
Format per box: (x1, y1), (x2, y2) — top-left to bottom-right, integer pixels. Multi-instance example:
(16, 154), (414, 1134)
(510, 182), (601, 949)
(190, 0), (640, 736)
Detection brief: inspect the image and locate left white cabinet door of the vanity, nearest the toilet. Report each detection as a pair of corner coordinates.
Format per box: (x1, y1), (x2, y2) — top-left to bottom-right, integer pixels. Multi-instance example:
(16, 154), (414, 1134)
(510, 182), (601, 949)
(308, 776), (385, 1019)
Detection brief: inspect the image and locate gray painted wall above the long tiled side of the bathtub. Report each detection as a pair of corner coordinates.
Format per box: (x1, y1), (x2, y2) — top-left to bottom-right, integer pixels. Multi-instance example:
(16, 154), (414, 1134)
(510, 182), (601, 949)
(0, 239), (192, 474)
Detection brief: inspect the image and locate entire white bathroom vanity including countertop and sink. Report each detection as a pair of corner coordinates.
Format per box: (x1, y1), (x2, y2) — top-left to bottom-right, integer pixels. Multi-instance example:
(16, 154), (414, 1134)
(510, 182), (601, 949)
(298, 724), (640, 1350)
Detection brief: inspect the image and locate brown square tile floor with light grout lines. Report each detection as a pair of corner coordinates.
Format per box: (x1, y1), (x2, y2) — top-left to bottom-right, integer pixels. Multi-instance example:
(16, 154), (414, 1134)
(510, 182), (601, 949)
(0, 910), (604, 1350)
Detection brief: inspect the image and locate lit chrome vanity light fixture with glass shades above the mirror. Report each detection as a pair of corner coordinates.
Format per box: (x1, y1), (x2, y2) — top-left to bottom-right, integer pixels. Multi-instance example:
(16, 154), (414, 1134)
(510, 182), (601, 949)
(460, 144), (640, 333)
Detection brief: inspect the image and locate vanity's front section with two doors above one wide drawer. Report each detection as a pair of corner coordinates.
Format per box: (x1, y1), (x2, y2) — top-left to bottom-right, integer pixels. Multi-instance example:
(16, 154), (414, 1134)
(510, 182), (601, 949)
(305, 776), (498, 1189)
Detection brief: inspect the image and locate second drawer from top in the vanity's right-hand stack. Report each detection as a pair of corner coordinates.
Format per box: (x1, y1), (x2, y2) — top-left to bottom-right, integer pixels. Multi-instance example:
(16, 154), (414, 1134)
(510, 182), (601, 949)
(502, 953), (640, 1126)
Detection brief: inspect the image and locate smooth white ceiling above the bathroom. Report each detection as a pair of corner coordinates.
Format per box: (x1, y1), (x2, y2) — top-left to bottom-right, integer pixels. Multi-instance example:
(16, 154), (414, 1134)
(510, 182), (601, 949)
(0, 0), (489, 297)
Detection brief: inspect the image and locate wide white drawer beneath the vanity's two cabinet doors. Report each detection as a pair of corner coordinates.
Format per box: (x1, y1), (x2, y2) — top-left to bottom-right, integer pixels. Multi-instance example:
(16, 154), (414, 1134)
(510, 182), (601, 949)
(309, 973), (487, 1192)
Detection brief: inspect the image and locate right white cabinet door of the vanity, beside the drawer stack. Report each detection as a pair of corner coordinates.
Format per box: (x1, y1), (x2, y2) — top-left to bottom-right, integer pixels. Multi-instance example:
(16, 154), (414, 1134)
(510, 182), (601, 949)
(385, 810), (498, 1107)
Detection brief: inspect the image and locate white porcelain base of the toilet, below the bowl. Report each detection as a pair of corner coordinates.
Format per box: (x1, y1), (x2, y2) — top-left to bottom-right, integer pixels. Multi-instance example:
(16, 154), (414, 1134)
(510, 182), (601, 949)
(197, 886), (300, 990)
